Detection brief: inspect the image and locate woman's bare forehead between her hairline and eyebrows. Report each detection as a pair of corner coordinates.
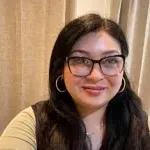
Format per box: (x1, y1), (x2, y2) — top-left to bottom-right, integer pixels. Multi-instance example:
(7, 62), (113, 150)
(72, 31), (121, 56)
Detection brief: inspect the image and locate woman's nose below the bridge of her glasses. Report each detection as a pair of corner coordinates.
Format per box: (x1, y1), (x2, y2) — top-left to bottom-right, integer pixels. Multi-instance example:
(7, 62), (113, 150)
(87, 63), (104, 81)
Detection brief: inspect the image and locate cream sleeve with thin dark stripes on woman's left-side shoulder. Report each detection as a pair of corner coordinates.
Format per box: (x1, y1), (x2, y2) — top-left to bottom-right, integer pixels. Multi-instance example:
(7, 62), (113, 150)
(0, 107), (36, 150)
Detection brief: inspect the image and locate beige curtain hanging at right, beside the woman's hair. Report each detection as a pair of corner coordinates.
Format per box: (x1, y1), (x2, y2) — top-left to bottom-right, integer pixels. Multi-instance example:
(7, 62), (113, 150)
(110, 0), (150, 115)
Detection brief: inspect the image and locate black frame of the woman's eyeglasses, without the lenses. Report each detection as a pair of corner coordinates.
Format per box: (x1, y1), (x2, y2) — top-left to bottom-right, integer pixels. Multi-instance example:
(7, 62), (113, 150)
(66, 55), (126, 77)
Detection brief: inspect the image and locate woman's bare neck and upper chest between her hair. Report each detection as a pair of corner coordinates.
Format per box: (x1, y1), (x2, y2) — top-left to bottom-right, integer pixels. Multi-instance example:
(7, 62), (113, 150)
(78, 106), (107, 149)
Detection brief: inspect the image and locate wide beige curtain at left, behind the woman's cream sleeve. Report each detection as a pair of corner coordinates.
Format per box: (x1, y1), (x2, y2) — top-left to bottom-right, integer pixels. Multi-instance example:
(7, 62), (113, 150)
(0, 0), (76, 133)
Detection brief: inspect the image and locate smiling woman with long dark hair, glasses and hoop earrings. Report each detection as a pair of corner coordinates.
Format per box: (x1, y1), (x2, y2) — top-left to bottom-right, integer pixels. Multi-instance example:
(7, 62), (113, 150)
(0, 14), (150, 150)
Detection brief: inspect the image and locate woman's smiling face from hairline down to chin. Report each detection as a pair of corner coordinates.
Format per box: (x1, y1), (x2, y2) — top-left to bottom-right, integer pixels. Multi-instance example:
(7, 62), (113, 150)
(63, 31), (123, 114)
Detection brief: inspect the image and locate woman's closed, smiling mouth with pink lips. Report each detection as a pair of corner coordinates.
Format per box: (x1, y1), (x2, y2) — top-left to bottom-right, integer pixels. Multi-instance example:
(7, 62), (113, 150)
(83, 86), (106, 96)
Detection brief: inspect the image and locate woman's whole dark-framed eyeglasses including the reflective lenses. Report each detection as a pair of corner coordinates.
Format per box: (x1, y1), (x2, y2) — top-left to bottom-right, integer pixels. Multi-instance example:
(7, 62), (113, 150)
(66, 55), (125, 77)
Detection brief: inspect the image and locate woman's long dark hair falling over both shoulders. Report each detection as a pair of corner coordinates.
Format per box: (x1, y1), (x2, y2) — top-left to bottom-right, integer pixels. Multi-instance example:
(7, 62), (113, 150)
(37, 14), (150, 150)
